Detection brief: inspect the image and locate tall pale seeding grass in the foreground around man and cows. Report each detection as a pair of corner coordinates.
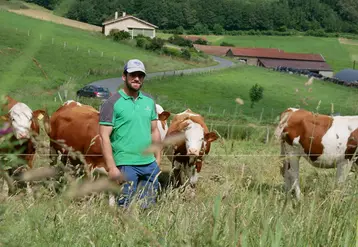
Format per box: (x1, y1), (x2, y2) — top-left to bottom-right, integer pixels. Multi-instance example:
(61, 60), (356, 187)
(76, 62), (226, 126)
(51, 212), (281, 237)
(0, 140), (358, 247)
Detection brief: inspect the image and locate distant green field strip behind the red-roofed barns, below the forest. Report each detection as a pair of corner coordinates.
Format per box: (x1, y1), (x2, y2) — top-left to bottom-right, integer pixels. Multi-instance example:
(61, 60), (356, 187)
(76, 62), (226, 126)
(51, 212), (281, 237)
(158, 33), (358, 72)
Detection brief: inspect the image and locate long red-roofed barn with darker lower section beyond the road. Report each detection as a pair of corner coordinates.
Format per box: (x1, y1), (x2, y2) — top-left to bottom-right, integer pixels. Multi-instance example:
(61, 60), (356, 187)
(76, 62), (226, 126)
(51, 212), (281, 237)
(226, 48), (333, 77)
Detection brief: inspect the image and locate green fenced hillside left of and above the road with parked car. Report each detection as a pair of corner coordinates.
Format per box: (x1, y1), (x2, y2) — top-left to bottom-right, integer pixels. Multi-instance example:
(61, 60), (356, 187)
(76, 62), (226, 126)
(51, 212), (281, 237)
(0, 10), (211, 109)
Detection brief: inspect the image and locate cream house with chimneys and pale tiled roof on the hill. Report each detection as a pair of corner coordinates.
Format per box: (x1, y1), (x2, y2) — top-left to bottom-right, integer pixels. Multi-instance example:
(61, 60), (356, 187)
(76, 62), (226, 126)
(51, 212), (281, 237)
(102, 12), (158, 38)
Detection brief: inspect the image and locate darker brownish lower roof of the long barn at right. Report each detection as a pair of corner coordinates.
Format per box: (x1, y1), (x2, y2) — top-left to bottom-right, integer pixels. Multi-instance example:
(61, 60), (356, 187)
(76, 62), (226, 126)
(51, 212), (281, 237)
(259, 58), (332, 71)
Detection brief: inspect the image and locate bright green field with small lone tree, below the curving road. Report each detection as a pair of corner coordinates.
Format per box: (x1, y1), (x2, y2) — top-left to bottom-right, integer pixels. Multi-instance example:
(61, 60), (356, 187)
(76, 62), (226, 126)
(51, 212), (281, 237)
(144, 66), (358, 122)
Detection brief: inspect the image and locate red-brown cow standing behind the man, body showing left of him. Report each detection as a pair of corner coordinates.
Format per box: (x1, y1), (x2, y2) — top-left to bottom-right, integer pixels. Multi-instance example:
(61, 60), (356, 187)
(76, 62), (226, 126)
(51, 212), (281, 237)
(47, 100), (170, 205)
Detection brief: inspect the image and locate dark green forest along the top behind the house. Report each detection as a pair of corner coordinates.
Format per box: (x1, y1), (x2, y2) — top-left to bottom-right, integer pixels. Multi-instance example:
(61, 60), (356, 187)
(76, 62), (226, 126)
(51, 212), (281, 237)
(27, 0), (358, 34)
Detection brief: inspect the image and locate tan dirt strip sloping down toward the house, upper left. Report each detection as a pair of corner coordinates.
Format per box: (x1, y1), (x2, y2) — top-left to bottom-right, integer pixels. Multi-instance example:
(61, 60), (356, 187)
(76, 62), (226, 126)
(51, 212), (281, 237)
(9, 9), (102, 32)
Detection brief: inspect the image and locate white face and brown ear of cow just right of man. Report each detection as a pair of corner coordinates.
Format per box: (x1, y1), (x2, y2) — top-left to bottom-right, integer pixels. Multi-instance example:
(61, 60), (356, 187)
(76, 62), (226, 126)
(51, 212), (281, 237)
(184, 120), (218, 156)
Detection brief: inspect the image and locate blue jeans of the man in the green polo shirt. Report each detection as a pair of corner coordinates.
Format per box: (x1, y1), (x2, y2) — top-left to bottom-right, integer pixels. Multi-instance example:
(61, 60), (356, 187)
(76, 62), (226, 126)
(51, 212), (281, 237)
(117, 161), (160, 208)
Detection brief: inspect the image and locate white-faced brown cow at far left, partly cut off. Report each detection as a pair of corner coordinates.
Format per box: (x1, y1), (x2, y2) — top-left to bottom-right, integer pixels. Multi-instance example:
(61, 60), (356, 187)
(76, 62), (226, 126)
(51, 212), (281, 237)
(0, 96), (48, 194)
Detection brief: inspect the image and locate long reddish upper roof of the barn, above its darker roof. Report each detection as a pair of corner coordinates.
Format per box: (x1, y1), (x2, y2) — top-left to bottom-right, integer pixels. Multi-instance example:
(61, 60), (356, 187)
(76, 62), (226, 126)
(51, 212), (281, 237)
(231, 48), (325, 62)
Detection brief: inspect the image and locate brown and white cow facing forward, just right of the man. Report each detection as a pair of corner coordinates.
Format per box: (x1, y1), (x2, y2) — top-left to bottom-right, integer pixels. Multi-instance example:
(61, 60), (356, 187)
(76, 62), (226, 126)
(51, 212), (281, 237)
(165, 109), (218, 187)
